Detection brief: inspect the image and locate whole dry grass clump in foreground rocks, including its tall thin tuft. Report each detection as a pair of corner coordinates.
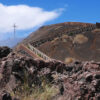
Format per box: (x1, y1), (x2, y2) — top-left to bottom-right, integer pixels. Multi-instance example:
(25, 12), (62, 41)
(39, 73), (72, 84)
(11, 74), (59, 100)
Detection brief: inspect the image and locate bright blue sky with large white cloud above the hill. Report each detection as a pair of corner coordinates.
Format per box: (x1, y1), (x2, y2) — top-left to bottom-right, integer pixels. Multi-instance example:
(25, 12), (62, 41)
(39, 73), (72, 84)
(0, 0), (100, 40)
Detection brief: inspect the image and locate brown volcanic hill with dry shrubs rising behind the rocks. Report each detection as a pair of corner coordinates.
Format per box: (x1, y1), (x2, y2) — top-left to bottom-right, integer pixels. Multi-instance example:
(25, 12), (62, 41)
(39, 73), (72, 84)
(22, 22), (100, 61)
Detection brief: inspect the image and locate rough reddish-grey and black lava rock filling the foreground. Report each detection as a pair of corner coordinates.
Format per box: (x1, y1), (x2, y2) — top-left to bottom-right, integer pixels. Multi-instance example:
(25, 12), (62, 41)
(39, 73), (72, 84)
(0, 48), (100, 100)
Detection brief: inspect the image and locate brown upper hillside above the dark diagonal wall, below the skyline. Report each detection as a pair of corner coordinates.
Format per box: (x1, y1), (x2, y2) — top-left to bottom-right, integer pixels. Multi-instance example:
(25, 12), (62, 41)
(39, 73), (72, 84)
(23, 22), (92, 43)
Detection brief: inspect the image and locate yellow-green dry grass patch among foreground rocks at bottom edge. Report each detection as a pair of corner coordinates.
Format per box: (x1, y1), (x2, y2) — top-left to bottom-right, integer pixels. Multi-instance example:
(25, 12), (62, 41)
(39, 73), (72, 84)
(12, 84), (59, 100)
